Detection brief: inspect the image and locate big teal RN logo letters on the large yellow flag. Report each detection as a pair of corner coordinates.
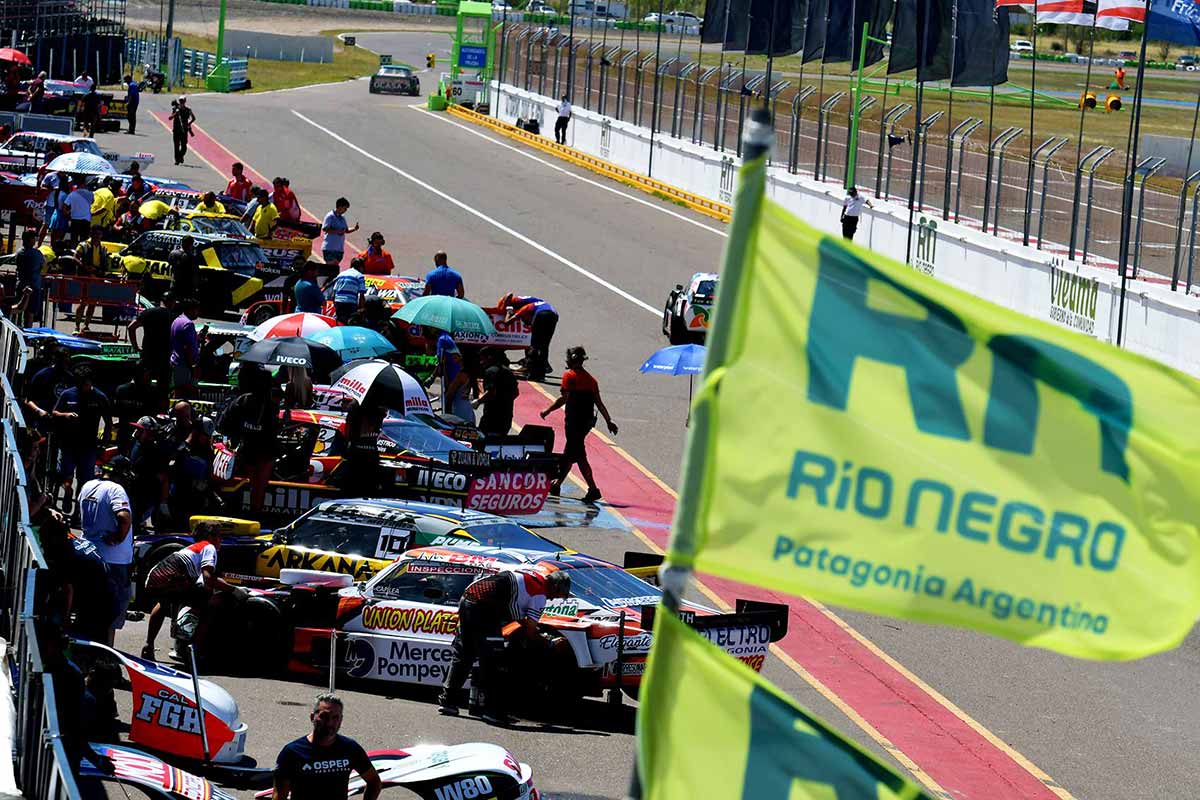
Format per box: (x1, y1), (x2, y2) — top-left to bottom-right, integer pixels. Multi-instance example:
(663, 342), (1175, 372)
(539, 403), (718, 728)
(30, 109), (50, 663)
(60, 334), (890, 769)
(806, 243), (1133, 483)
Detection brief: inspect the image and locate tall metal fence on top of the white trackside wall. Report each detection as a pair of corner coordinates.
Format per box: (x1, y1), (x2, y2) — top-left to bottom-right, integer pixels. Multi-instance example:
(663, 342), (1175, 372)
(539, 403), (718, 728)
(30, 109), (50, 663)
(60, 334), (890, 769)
(497, 19), (1200, 289)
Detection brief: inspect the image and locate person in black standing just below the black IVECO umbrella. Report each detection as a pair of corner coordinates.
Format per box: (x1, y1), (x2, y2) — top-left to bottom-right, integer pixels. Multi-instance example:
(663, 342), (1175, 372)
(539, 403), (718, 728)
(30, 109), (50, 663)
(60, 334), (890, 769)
(217, 363), (280, 513)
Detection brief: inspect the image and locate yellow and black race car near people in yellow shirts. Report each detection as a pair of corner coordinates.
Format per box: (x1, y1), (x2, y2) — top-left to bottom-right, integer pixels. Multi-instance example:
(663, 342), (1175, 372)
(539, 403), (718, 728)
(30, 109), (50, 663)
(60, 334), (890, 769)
(110, 230), (268, 319)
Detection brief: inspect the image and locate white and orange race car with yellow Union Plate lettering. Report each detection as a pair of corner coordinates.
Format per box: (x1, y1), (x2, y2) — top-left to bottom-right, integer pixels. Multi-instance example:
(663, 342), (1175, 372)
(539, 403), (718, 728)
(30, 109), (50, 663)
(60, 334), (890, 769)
(200, 547), (788, 705)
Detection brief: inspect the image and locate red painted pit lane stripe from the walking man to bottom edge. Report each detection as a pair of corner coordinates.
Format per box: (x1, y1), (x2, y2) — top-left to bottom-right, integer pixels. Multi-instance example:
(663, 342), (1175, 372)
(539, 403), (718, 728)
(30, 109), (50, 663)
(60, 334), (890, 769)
(514, 383), (1072, 800)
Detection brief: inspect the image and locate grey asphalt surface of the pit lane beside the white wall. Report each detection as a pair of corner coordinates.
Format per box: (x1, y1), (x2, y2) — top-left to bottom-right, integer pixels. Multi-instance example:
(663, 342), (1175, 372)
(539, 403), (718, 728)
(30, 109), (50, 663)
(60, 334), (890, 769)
(102, 34), (1200, 799)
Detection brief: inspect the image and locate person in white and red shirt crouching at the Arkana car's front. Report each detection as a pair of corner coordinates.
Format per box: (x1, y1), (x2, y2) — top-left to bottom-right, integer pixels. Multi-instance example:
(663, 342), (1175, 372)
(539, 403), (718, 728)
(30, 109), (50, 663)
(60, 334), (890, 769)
(142, 523), (250, 661)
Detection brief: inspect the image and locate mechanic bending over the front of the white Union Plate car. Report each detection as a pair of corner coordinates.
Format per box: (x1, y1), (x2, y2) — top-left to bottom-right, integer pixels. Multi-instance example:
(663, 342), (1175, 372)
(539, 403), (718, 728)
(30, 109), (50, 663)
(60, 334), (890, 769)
(438, 570), (571, 724)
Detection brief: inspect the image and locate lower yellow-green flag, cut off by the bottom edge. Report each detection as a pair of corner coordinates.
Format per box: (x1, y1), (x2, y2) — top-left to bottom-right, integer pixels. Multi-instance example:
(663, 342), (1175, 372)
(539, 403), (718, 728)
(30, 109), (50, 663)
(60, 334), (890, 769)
(637, 612), (928, 800)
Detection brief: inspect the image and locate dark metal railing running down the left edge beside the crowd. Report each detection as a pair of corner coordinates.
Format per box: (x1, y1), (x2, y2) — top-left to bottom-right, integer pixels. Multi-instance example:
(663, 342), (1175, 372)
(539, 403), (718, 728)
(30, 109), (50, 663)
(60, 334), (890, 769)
(0, 317), (80, 800)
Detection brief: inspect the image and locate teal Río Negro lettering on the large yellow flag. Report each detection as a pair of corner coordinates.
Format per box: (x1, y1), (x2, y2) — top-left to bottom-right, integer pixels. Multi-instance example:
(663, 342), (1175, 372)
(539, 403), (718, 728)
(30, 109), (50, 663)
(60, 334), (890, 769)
(774, 450), (1126, 572)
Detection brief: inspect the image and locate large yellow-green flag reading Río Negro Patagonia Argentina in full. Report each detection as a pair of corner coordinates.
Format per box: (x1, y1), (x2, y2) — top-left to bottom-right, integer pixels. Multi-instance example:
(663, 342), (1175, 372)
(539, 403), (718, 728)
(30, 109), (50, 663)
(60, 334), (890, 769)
(668, 158), (1200, 658)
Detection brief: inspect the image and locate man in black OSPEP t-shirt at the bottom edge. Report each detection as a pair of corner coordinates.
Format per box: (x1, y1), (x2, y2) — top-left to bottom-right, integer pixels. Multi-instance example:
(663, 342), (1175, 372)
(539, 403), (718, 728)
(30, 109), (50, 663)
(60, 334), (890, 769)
(271, 694), (383, 800)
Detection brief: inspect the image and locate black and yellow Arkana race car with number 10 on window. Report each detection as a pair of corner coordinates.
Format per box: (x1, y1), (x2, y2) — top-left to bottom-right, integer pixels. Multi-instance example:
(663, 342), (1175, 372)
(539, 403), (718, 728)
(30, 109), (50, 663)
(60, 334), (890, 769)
(133, 498), (571, 585)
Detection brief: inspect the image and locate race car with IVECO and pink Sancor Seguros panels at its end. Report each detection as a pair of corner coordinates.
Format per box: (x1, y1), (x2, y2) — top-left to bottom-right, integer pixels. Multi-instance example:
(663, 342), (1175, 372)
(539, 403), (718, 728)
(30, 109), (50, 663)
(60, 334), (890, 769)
(212, 410), (557, 522)
